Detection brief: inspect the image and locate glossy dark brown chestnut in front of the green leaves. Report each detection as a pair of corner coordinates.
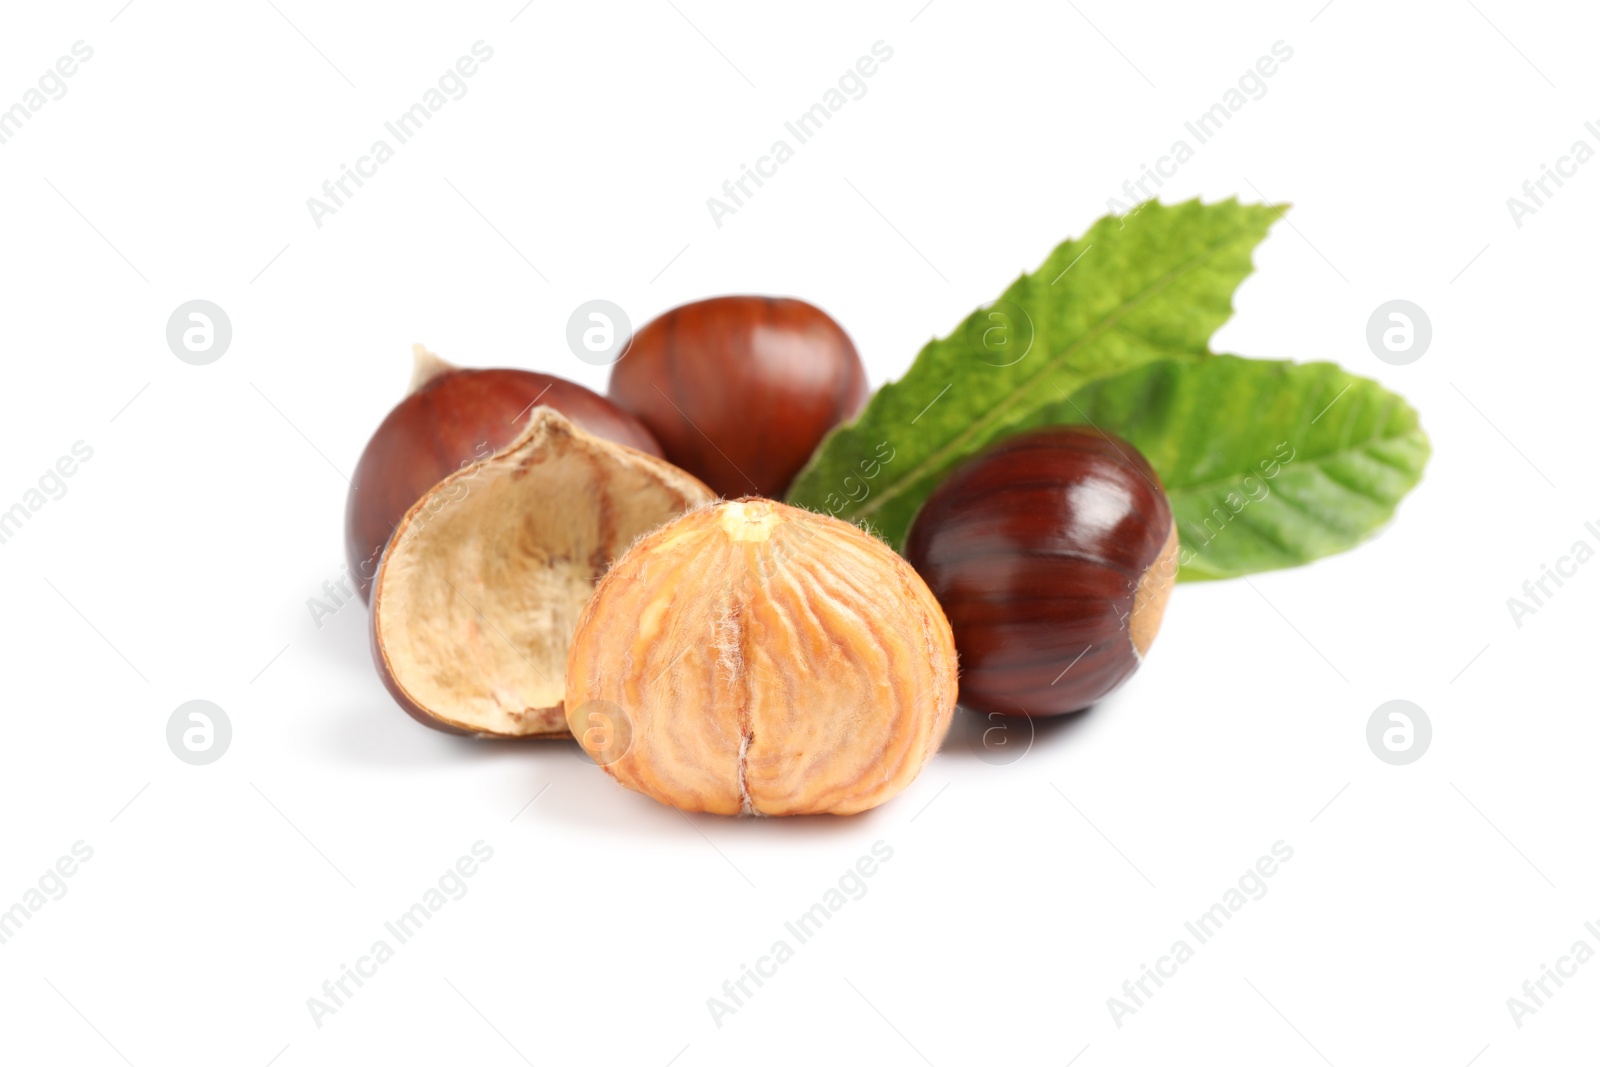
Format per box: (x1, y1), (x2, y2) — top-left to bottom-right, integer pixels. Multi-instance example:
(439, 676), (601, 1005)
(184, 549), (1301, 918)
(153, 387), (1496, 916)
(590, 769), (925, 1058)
(906, 427), (1178, 715)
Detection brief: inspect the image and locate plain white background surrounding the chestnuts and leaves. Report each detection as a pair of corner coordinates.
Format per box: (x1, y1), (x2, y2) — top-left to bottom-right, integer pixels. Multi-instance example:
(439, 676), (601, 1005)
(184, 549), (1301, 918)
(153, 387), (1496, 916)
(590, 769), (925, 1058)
(0, 0), (1600, 1067)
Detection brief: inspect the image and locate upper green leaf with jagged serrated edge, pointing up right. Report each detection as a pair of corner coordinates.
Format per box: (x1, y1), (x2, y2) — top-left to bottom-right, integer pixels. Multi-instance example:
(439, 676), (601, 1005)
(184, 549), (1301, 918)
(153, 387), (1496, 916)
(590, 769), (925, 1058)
(787, 200), (1280, 547)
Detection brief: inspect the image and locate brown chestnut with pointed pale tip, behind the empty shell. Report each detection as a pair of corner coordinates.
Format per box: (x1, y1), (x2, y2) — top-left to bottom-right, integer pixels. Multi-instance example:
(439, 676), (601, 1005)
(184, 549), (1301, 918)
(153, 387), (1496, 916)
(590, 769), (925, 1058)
(344, 346), (661, 600)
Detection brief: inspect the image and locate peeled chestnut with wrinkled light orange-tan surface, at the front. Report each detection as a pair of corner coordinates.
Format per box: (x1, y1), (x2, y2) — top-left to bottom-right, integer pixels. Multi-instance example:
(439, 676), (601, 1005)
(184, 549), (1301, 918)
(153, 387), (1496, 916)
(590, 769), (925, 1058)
(566, 499), (957, 816)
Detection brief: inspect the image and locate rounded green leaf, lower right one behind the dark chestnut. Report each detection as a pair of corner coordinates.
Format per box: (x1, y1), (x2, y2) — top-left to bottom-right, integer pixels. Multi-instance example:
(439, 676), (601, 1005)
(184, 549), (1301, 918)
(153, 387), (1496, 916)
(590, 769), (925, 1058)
(1048, 355), (1429, 581)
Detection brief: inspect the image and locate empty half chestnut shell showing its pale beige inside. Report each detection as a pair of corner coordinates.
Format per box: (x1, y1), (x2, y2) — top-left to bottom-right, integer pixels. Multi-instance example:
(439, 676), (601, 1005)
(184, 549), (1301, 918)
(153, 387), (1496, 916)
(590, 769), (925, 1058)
(371, 406), (712, 737)
